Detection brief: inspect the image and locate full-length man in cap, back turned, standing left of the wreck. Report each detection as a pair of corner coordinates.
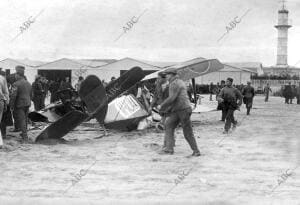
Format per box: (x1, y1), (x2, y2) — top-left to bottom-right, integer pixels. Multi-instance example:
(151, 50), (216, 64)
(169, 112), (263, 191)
(10, 66), (32, 141)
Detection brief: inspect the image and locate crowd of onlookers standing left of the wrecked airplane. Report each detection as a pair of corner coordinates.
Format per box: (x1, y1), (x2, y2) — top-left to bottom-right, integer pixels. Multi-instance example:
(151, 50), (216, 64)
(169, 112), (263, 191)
(0, 66), (88, 148)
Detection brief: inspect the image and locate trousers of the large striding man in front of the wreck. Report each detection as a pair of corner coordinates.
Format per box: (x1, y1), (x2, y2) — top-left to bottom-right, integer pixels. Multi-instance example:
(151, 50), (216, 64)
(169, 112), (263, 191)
(165, 108), (199, 152)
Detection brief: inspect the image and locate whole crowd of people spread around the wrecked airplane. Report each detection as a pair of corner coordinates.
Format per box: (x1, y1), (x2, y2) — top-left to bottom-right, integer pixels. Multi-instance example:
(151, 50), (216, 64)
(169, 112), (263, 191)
(0, 66), (300, 156)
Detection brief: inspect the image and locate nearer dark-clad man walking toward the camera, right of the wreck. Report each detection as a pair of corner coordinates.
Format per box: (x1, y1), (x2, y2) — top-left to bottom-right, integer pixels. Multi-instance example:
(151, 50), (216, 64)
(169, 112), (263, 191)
(218, 78), (243, 134)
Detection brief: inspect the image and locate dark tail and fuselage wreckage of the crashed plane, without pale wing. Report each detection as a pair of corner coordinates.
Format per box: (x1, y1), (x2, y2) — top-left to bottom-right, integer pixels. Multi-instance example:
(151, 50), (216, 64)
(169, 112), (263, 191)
(29, 67), (149, 142)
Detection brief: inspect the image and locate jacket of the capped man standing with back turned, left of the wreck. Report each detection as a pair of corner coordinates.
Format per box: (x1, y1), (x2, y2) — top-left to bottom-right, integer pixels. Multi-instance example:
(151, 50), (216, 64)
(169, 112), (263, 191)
(10, 79), (32, 108)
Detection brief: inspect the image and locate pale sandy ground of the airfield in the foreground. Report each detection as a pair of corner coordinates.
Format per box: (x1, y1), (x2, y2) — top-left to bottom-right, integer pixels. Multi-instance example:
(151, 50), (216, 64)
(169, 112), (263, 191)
(0, 96), (300, 205)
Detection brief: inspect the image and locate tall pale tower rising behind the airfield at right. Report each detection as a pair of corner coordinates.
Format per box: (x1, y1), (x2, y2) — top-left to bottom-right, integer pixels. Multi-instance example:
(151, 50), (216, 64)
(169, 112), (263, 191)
(275, 0), (292, 67)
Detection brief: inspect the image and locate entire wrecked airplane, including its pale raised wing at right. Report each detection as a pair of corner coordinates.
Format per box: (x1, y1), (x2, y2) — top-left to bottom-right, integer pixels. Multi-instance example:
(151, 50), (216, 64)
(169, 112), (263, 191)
(31, 58), (223, 142)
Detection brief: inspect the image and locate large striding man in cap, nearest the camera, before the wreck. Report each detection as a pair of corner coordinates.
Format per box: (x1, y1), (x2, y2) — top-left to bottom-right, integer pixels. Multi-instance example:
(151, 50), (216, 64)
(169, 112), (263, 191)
(157, 70), (200, 156)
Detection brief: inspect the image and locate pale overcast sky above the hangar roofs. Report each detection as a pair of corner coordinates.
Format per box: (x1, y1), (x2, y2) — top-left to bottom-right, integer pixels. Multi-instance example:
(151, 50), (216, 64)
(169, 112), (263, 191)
(0, 0), (300, 66)
